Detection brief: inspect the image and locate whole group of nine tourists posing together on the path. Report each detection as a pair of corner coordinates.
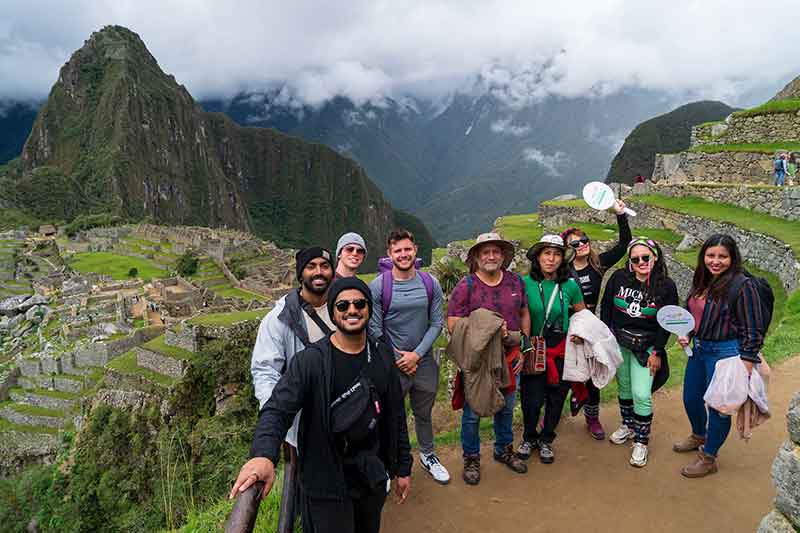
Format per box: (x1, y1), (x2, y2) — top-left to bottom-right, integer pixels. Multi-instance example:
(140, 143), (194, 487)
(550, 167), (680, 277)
(231, 200), (770, 533)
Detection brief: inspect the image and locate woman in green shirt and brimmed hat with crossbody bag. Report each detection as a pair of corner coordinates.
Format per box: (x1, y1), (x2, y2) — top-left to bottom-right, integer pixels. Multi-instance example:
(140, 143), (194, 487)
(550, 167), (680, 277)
(517, 235), (586, 464)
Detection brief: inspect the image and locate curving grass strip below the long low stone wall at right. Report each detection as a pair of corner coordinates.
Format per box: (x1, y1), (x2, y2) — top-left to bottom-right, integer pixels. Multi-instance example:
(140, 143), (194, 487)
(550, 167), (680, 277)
(636, 194), (800, 257)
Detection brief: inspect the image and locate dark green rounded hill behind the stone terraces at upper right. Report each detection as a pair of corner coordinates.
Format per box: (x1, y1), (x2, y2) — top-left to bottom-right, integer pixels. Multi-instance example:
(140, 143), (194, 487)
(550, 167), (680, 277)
(607, 101), (736, 183)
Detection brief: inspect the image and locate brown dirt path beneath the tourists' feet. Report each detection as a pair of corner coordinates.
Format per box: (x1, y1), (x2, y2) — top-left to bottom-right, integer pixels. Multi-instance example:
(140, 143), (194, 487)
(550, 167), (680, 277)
(381, 357), (800, 533)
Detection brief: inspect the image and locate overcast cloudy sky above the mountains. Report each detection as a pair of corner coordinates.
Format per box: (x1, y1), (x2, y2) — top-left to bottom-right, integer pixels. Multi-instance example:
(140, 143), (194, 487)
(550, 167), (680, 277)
(0, 0), (800, 105)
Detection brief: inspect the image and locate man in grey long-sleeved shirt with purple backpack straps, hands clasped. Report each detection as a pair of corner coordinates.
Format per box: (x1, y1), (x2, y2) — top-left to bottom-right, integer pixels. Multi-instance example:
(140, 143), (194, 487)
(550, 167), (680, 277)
(369, 230), (450, 484)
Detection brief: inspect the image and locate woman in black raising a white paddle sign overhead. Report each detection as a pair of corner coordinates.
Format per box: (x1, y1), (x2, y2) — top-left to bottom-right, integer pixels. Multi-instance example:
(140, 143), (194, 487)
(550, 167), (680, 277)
(561, 200), (631, 440)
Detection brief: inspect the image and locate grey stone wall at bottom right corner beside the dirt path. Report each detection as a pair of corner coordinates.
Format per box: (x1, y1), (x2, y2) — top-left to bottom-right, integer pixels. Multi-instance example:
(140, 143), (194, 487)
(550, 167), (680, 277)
(758, 392), (800, 533)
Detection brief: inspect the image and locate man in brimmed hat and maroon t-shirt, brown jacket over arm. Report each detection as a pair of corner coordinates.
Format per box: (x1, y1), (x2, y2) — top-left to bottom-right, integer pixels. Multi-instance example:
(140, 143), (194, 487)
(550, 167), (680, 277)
(447, 233), (531, 485)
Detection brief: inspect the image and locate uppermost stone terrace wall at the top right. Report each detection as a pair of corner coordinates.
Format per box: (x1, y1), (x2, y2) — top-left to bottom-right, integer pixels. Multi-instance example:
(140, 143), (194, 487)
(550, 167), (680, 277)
(691, 112), (800, 146)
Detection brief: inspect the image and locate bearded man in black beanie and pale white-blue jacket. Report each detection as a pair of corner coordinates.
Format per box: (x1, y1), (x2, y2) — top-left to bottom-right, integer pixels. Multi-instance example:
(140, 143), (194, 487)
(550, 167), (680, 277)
(250, 246), (335, 533)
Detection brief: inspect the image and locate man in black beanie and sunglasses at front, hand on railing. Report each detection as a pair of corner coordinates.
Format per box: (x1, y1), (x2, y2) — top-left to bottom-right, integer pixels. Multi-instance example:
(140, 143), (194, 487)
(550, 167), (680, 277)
(230, 278), (412, 533)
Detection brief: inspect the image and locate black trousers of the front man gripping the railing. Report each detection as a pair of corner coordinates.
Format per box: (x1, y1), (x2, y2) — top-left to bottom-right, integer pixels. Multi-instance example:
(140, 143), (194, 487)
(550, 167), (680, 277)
(303, 488), (386, 533)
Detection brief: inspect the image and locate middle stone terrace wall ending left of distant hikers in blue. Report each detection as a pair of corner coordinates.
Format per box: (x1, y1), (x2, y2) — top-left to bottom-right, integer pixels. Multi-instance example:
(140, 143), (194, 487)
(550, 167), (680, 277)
(651, 152), (773, 184)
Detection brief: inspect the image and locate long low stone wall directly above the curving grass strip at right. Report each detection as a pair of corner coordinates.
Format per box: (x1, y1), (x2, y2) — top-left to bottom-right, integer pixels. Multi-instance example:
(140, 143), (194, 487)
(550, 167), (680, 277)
(650, 182), (800, 220)
